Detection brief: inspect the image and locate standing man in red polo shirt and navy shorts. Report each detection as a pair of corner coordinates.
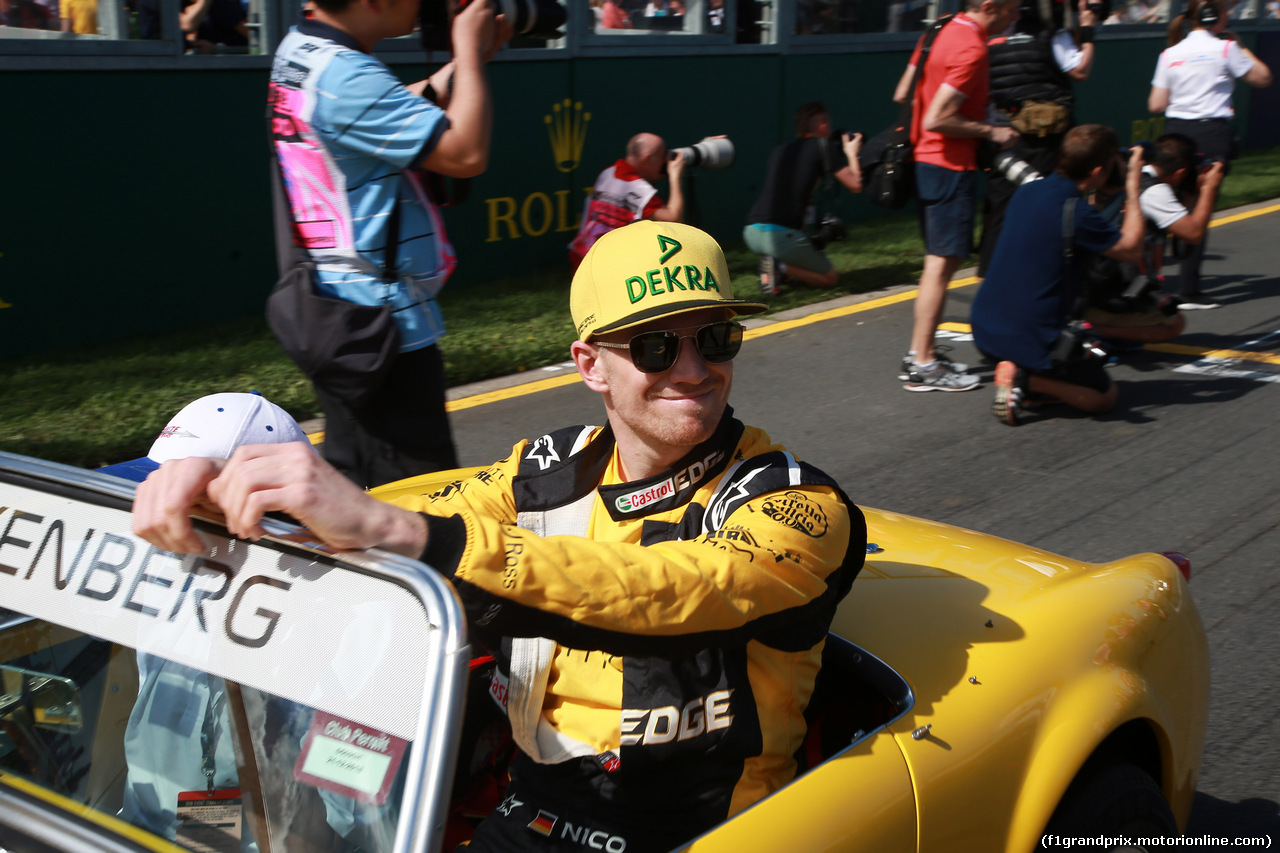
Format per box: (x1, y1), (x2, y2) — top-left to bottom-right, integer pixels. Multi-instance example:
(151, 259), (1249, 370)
(893, 0), (1018, 391)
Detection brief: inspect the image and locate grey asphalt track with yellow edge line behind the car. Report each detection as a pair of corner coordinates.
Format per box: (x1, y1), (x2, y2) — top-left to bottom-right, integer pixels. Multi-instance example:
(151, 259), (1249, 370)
(451, 202), (1280, 843)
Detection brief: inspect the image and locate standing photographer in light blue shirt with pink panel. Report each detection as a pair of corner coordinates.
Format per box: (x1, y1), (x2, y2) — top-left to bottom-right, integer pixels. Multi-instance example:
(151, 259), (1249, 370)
(269, 0), (512, 488)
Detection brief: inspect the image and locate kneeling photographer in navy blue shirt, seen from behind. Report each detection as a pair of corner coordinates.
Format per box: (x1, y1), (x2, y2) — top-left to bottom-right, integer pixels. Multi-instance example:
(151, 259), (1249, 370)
(970, 124), (1143, 427)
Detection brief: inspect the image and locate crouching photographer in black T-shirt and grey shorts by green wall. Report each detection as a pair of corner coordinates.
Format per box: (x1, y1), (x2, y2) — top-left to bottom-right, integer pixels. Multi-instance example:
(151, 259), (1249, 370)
(742, 101), (863, 296)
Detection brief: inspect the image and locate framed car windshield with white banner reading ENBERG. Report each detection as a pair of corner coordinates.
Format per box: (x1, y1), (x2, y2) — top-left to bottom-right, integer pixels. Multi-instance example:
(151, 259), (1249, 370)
(0, 455), (468, 853)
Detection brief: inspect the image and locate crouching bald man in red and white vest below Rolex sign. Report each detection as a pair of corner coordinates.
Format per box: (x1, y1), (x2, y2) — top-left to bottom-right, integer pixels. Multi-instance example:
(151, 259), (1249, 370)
(568, 133), (685, 270)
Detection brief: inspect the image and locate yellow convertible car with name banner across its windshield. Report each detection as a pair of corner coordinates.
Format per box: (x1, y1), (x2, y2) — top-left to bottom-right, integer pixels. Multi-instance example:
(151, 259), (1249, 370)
(0, 453), (1208, 853)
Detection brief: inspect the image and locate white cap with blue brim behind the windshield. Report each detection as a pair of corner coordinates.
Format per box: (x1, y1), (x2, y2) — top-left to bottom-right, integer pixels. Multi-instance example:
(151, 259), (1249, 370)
(99, 393), (310, 483)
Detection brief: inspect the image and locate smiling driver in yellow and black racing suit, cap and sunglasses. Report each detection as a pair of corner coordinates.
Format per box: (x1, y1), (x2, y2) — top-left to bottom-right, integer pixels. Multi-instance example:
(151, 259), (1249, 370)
(134, 222), (867, 853)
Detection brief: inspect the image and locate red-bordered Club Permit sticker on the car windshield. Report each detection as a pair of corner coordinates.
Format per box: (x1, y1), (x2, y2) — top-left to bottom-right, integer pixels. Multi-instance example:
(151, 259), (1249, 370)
(293, 711), (408, 806)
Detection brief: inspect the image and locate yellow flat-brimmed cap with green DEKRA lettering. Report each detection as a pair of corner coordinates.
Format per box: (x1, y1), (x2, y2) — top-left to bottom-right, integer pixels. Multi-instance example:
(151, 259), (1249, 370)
(568, 219), (769, 341)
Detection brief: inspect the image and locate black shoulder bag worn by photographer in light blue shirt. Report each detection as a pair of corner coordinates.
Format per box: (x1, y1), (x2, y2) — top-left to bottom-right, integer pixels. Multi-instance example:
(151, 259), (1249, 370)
(266, 156), (401, 409)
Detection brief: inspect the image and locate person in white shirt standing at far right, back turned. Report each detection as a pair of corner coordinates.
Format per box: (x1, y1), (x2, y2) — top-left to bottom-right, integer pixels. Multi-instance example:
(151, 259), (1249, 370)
(1147, 0), (1271, 310)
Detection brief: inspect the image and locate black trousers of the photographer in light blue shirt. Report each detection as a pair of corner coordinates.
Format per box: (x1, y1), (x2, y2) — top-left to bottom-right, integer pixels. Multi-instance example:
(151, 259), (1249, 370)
(315, 345), (458, 488)
